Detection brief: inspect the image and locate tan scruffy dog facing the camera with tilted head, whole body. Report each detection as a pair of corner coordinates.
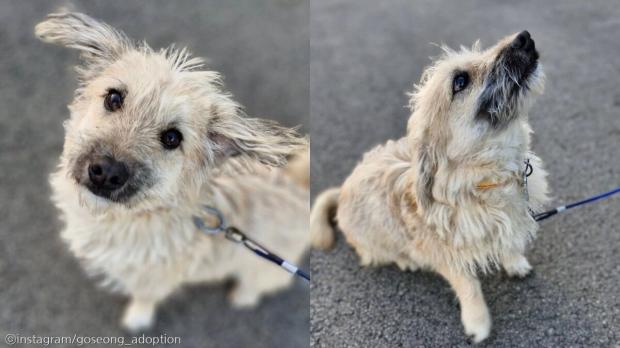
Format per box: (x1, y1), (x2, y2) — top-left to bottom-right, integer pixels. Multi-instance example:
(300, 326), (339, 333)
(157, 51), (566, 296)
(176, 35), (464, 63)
(35, 13), (310, 330)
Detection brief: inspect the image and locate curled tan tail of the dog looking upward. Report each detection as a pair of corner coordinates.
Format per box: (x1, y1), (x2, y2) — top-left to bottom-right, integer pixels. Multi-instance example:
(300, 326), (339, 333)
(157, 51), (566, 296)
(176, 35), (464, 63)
(310, 187), (340, 249)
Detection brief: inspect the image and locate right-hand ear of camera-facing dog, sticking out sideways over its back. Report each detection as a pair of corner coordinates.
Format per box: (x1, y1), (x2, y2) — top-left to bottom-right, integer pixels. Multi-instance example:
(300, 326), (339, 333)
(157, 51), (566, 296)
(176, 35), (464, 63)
(208, 115), (308, 167)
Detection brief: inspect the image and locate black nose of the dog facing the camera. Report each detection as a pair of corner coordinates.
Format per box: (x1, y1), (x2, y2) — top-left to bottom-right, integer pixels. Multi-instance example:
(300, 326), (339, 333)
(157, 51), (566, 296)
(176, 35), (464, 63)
(88, 157), (129, 192)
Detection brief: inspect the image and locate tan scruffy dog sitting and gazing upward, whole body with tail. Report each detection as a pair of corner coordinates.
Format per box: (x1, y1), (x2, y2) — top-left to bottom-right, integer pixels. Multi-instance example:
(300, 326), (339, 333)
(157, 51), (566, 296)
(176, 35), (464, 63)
(310, 31), (547, 342)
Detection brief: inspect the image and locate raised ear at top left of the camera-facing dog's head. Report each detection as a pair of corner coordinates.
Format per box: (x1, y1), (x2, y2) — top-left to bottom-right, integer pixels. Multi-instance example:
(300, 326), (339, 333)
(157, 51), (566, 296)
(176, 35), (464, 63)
(34, 13), (133, 63)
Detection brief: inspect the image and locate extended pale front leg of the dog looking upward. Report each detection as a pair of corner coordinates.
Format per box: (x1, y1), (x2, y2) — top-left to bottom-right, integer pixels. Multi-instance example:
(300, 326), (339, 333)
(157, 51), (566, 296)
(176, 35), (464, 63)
(438, 267), (491, 343)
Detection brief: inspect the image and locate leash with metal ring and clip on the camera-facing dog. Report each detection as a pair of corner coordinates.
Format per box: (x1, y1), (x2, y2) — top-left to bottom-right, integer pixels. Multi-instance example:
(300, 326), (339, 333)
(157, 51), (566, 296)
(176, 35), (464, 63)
(192, 205), (310, 281)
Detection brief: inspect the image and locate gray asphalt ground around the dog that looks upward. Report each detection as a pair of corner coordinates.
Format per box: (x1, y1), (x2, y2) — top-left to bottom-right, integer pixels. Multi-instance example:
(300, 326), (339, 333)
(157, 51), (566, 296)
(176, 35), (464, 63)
(310, 0), (620, 347)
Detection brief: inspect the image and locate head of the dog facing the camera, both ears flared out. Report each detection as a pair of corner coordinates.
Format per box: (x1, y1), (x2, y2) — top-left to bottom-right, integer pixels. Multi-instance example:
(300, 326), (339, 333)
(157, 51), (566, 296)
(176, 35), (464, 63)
(35, 13), (305, 207)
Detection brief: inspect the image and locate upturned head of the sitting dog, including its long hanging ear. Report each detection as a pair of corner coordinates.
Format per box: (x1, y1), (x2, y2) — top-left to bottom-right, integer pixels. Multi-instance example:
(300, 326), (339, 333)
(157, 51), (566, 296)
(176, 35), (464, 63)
(408, 31), (544, 211)
